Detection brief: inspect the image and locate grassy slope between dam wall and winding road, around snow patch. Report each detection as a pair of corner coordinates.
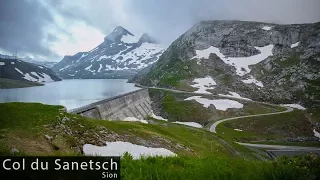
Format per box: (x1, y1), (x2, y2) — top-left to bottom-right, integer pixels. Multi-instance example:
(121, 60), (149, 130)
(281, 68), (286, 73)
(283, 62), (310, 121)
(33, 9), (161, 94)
(149, 89), (286, 126)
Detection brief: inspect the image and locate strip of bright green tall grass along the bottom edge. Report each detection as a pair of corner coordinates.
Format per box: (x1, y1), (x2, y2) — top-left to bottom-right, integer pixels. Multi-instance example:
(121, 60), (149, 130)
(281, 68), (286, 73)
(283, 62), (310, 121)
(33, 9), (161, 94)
(121, 156), (320, 180)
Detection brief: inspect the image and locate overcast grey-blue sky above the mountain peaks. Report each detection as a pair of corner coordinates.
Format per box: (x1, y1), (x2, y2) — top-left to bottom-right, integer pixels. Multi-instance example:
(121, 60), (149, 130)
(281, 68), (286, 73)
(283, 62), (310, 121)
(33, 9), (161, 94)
(0, 0), (320, 61)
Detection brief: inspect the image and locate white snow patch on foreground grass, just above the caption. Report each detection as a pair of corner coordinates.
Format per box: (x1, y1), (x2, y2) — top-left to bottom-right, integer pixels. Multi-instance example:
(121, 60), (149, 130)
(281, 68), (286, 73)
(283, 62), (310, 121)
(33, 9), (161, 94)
(83, 141), (176, 159)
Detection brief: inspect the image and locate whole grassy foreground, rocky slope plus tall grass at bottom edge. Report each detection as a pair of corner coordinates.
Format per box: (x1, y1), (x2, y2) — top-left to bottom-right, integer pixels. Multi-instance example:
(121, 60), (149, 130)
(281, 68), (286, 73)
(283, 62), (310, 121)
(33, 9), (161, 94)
(0, 103), (320, 180)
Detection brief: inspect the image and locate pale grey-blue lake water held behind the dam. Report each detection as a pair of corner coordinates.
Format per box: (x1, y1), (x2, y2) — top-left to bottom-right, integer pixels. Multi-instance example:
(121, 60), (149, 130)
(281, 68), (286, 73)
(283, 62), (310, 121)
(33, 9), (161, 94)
(0, 79), (139, 110)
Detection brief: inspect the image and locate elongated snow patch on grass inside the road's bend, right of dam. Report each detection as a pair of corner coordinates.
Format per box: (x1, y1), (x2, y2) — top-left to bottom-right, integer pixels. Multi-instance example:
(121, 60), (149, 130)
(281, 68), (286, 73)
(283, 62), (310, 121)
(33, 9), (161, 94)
(185, 96), (243, 111)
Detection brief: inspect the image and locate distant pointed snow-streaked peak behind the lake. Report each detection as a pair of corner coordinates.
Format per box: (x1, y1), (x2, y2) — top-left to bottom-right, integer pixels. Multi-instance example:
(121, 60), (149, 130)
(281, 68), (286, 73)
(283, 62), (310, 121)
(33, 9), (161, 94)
(53, 26), (164, 78)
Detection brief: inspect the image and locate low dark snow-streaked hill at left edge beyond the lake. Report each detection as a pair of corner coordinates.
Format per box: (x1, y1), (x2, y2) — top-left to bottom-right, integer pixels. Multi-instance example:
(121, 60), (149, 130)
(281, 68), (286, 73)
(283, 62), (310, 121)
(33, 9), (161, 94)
(0, 56), (61, 82)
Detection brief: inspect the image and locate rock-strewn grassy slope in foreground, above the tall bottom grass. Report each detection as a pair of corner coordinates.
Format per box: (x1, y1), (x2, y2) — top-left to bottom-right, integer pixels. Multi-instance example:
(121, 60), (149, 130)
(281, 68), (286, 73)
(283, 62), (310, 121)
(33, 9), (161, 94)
(0, 103), (229, 156)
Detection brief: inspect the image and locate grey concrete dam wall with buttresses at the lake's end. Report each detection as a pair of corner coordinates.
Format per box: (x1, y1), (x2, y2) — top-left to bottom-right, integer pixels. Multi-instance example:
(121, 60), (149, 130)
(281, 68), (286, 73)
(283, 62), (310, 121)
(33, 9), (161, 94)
(70, 88), (152, 120)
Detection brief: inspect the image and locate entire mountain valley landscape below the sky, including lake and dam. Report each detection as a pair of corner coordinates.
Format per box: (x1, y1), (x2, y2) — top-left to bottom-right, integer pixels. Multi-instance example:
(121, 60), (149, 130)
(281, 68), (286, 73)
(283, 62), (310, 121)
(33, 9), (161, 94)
(0, 16), (320, 179)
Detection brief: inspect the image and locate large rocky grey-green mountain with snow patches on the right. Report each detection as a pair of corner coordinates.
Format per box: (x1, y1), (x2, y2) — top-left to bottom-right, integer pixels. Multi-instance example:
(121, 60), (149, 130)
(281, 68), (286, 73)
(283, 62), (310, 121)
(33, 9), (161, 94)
(132, 21), (320, 107)
